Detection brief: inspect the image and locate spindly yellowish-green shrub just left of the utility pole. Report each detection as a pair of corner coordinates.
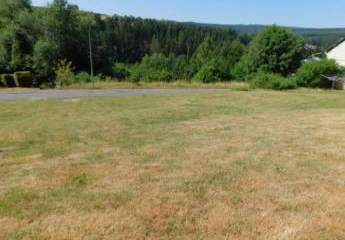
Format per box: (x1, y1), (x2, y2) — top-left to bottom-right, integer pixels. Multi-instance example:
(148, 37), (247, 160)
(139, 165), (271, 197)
(55, 60), (75, 87)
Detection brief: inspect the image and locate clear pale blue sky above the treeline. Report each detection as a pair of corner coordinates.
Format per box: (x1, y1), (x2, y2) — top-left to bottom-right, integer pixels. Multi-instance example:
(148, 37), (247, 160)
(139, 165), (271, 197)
(32, 0), (345, 27)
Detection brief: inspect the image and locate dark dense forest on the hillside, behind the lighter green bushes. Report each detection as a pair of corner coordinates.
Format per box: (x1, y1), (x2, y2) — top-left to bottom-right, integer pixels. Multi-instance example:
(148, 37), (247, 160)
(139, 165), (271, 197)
(0, 0), (241, 83)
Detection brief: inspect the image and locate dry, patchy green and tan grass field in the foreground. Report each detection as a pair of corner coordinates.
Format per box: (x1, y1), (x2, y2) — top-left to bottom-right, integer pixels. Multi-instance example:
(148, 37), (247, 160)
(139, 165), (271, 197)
(0, 90), (345, 240)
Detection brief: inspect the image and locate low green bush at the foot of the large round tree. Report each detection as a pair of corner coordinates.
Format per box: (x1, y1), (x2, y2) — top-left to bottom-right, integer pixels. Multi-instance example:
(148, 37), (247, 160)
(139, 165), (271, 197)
(250, 73), (297, 90)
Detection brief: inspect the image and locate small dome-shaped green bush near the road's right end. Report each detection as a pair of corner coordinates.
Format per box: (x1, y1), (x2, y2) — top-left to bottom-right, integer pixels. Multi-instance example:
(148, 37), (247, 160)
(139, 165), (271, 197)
(193, 63), (223, 83)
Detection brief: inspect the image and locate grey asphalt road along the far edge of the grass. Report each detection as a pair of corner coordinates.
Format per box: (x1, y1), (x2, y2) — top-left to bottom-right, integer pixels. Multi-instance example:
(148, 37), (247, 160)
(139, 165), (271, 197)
(0, 89), (226, 101)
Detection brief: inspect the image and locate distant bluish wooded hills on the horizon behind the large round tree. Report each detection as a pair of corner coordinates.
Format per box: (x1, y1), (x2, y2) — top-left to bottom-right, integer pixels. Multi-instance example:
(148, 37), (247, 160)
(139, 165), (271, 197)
(185, 22), (345, 49)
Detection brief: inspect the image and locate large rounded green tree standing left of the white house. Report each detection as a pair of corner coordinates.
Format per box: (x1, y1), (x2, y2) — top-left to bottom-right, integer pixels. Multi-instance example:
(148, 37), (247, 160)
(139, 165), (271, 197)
(243, 26), (305, 76)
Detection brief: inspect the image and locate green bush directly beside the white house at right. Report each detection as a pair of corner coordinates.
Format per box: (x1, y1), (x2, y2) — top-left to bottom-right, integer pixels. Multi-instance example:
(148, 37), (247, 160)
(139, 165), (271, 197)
(296, 59), (343, 88)
